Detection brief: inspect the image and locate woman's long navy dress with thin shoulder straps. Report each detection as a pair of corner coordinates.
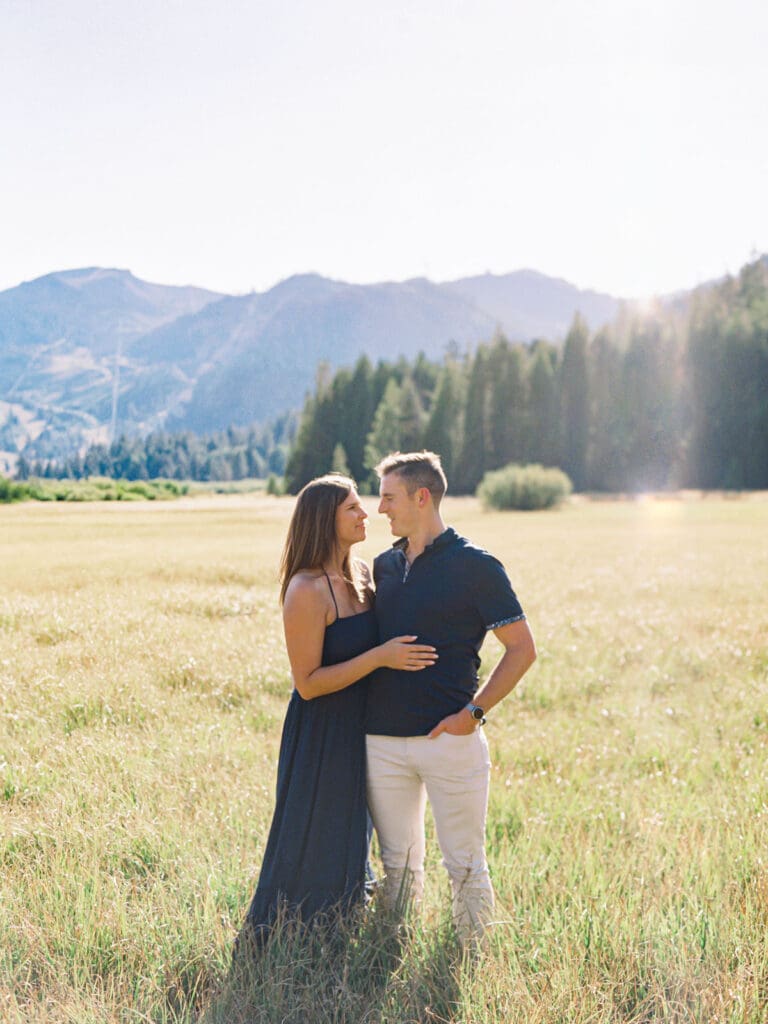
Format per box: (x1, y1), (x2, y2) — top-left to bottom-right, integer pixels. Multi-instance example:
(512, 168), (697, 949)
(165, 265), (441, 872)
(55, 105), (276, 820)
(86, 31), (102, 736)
(239, 581), (378, 941)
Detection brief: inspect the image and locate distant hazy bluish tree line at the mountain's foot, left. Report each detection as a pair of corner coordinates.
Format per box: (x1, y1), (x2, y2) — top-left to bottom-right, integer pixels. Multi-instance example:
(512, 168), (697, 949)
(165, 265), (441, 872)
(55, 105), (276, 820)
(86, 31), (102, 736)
(16, 413), (296, 481)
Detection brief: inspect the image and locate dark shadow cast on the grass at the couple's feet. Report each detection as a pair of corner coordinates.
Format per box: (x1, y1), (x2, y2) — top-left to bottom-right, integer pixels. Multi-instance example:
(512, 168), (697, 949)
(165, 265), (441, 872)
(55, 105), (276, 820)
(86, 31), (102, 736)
(198, 911), (460, 1024)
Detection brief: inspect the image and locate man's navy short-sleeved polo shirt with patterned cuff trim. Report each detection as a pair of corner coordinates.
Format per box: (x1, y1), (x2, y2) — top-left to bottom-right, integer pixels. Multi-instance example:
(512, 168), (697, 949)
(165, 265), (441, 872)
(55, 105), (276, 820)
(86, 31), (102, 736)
(366, 527), (525, 736)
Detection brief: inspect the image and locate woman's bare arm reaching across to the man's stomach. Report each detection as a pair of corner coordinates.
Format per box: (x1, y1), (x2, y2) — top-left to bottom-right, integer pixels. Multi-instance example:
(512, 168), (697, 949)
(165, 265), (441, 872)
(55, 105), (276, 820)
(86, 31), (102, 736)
(283, 575), (437, 700)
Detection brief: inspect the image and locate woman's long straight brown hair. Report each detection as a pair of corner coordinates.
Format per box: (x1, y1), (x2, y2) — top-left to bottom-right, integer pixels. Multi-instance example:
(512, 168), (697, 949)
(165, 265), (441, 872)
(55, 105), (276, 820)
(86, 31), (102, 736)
(280, 473), (355, 604)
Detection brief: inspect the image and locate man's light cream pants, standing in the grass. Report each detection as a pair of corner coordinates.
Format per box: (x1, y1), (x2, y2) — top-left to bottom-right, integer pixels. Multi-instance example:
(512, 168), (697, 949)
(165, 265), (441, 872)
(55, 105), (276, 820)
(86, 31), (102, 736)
(366, 729), (494, 943)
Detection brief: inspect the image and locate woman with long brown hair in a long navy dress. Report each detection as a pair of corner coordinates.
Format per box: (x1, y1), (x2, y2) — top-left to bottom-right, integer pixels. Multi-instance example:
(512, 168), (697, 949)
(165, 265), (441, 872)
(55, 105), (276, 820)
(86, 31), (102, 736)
(242, 474), (436, 944)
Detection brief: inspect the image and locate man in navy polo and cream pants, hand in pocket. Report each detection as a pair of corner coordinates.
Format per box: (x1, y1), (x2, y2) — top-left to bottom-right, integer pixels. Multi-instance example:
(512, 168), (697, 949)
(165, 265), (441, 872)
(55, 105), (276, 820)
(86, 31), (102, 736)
(366, 452), (536, 945)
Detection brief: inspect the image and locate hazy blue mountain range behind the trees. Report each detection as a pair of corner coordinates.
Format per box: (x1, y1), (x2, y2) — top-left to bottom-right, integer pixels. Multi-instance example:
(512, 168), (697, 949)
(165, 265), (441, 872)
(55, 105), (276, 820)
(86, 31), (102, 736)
(0, 267), (621, 471)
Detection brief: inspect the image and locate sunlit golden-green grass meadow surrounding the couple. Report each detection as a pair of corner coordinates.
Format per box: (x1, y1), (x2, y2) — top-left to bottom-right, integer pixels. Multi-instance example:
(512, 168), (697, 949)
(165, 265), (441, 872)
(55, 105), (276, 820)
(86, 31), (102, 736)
(0, 495), (768, 1024)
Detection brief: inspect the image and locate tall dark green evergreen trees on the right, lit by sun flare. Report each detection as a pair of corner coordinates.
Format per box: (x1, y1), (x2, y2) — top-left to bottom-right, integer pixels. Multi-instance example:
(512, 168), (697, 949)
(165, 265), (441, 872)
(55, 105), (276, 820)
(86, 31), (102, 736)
(286, 260), (768, 494)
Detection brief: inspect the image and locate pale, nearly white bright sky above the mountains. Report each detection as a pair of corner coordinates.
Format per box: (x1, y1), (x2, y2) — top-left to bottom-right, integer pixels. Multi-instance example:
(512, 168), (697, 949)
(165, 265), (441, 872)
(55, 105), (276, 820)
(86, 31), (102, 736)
(0, 0), (768, 296)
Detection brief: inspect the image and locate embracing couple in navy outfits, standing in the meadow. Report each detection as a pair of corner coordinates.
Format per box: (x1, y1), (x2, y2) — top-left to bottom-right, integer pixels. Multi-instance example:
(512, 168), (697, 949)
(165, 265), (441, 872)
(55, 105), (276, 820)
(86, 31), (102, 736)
(239, 452), (536, 946)
